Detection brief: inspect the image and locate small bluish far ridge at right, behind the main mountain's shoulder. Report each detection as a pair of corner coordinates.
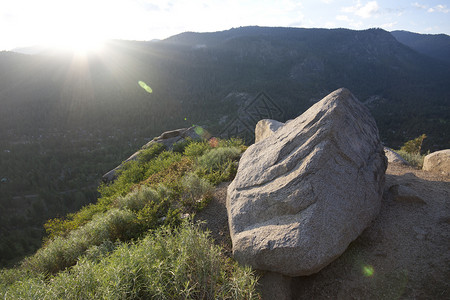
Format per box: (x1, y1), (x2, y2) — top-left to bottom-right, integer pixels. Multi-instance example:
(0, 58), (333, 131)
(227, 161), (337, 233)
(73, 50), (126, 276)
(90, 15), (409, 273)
(391, 30), (450, 63)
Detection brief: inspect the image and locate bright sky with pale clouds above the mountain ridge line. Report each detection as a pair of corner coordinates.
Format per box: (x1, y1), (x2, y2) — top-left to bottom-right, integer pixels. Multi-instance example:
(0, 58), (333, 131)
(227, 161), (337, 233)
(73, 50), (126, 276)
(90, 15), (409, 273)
(0, 0), (450, 50)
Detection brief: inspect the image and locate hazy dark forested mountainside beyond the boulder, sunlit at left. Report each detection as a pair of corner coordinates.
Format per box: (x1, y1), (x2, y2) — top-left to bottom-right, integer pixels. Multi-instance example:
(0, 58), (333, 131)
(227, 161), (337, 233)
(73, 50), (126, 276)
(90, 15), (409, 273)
(0, 27), (450, 264)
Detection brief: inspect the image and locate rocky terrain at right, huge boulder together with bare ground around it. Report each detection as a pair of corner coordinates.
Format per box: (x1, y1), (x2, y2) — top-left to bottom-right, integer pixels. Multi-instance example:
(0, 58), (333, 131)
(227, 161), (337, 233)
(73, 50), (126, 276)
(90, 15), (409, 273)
(198, 89), (450, 299)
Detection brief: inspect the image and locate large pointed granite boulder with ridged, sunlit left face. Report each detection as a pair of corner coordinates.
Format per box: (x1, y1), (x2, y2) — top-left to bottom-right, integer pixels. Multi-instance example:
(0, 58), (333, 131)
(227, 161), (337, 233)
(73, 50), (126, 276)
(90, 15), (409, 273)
(226, 89), (387, 276)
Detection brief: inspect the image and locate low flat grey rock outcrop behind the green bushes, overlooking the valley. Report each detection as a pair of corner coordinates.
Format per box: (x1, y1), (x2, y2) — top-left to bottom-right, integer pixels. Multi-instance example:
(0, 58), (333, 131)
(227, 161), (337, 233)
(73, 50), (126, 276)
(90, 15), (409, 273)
(102, 126), (203, 183)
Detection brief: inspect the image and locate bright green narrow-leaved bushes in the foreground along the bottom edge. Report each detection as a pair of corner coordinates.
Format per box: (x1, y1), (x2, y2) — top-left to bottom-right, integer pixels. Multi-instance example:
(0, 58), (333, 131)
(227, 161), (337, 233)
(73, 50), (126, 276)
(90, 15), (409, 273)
(0, 222), (260, 299)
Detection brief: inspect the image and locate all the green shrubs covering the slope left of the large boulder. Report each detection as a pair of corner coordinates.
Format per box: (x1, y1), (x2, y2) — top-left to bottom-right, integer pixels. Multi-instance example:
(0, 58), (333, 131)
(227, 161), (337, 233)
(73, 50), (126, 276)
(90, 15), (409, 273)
(0, 140), (259, 299)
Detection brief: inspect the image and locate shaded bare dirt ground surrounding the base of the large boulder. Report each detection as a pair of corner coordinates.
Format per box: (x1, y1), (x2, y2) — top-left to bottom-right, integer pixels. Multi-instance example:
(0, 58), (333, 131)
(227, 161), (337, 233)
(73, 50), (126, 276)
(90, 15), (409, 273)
(197, 164), (450, 299)
